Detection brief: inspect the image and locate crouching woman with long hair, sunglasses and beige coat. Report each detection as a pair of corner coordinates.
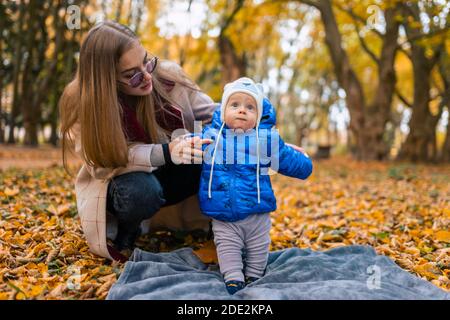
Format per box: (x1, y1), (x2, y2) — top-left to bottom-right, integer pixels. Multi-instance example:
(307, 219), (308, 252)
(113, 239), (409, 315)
(60, 21), (218, 260)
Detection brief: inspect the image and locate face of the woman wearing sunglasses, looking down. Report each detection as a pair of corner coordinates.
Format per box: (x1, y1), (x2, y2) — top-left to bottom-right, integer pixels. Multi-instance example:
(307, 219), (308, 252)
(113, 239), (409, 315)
(117, 44), (153, 96)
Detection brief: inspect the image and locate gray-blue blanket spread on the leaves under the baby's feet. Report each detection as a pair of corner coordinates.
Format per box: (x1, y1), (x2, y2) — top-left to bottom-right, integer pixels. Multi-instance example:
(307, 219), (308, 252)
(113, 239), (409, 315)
(107, 246), (450, 300)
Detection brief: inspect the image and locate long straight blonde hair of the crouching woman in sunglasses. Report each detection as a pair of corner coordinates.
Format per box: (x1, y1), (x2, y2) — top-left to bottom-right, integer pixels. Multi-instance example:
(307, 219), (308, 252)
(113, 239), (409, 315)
(59, 21), (198, 174)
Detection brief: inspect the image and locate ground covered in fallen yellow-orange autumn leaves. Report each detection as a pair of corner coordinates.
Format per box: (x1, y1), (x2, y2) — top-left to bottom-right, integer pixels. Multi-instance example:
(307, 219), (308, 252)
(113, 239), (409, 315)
(0, 158), (450, 299)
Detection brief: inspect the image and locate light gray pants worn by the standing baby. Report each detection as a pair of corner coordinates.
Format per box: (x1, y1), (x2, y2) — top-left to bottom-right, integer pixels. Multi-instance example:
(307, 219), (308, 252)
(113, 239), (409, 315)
(212, 213), (272, 281)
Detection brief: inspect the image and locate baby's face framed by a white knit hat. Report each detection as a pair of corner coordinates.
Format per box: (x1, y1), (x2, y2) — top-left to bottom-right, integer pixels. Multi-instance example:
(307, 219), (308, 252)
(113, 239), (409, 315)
(224, 92), (258, 131)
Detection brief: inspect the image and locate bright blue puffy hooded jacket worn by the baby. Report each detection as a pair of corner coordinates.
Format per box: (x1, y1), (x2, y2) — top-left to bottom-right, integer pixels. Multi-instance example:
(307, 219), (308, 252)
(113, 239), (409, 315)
(198, 99), (312, 222)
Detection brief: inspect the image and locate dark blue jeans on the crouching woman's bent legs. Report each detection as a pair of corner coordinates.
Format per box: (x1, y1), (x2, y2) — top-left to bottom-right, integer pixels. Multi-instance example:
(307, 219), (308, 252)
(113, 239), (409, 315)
(106, 164), (201, 250)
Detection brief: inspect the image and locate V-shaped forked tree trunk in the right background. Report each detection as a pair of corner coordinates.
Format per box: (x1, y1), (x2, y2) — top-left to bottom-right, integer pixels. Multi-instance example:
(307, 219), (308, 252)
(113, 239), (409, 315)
(302, 0), (399, 160)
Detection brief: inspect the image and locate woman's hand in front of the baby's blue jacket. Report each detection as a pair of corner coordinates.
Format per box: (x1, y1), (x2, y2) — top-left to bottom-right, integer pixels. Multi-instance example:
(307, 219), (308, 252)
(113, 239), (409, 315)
(169, 135), (213, 164)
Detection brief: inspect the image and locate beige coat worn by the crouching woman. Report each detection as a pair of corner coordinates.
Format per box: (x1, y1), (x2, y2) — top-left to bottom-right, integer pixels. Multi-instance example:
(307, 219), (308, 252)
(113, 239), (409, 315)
(71, 65), (218, 260)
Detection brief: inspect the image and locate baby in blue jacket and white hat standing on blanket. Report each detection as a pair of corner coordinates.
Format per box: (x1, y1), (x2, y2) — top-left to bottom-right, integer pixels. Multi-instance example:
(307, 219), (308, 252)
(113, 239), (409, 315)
(198, 78), (312, 294)
